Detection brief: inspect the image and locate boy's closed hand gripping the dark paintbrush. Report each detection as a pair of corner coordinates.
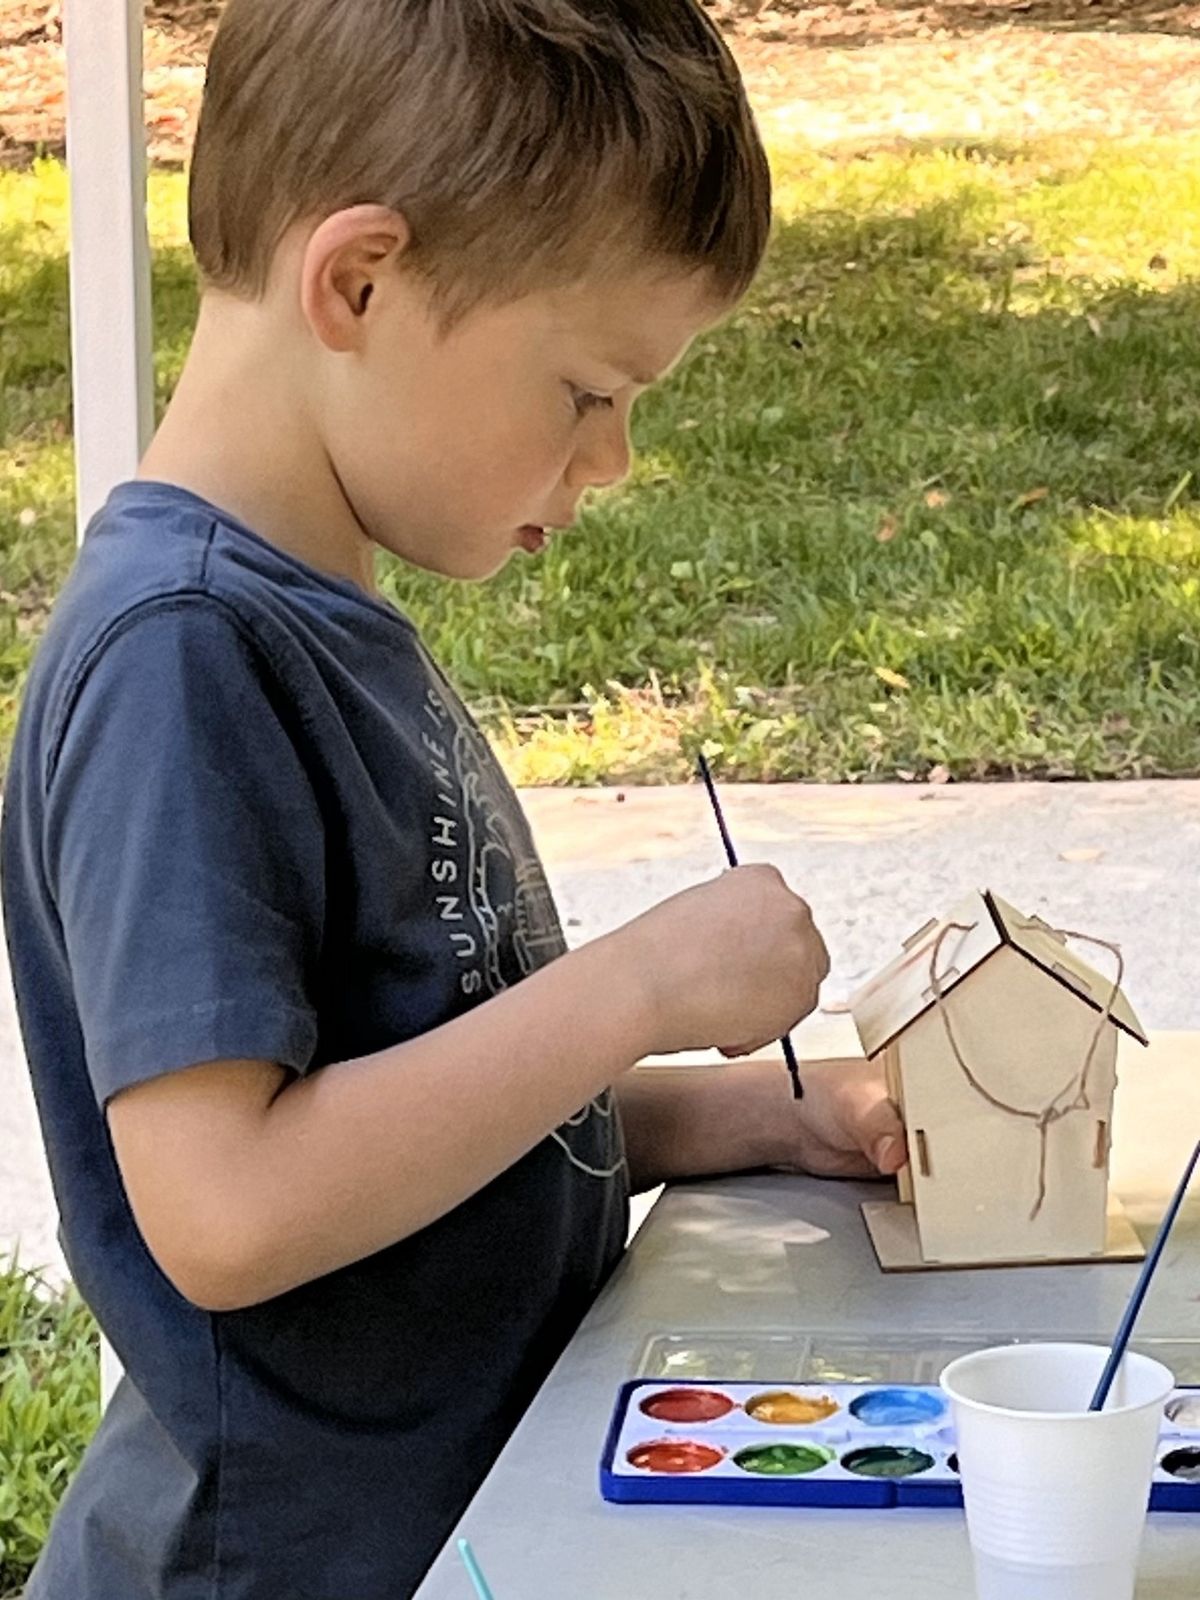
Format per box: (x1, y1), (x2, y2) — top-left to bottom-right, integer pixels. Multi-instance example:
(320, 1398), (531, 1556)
(613, 866), (829, 1056)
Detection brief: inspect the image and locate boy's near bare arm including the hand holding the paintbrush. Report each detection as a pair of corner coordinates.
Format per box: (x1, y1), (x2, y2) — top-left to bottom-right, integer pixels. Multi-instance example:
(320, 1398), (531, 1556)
(107, 867), (829, 1310)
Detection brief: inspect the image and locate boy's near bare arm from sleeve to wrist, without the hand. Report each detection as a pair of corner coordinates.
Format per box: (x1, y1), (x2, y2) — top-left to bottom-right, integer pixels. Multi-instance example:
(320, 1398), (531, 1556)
(109, 938), (650, 1310)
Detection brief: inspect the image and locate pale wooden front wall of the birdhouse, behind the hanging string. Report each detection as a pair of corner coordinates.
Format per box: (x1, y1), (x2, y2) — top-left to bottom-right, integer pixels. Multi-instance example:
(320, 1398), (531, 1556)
(898, 949), (1117, 1262)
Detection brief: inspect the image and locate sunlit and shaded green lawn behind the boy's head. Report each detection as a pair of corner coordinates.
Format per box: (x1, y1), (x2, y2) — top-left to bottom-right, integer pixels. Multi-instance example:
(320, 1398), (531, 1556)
(0, 136), (1200, 782)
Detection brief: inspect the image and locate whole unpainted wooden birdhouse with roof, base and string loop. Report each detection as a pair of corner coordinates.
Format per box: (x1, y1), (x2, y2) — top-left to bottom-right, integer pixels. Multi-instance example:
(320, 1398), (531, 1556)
(850, 891), (1147, 1270)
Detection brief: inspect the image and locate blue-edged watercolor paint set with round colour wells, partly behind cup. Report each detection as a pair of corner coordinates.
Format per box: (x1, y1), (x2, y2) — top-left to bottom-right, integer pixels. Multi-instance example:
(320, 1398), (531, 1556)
(600, 1378), (1200, 1512)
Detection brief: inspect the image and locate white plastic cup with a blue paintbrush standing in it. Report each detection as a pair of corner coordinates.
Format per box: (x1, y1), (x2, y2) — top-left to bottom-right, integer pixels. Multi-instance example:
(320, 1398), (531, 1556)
(941, 1344), (1174, 1600)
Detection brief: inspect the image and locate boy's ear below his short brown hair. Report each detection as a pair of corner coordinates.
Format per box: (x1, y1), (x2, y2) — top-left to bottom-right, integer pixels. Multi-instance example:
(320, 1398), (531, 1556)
(301, 205), (411, 354)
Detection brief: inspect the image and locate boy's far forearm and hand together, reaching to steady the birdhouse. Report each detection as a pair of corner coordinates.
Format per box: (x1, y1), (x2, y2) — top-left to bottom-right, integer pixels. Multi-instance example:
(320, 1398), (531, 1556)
(616, 1058), (907, 1190)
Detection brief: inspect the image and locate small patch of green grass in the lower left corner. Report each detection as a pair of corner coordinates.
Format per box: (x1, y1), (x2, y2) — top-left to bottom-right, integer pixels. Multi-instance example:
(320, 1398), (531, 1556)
(0, 1261), (99, 1597)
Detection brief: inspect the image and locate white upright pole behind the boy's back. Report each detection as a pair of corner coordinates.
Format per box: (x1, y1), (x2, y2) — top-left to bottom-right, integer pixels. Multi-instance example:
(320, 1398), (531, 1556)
(64, 0), (154, 1405)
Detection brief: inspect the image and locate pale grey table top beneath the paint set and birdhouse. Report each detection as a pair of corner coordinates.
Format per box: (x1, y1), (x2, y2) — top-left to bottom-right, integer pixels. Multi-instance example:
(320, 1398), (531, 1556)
(418, 1034), (1200, 1600)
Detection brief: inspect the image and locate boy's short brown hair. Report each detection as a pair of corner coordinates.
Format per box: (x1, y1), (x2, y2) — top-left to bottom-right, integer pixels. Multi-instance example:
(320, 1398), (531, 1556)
(189, 0), (771, 318)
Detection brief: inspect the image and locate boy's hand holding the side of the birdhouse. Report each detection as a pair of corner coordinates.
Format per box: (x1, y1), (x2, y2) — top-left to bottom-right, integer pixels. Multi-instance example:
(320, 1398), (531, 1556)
(771, 1058), (909, 1178)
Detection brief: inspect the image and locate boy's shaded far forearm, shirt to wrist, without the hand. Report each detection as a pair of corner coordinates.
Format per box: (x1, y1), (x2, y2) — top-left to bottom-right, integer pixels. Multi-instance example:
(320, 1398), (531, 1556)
(616, 1059), (790, 1190)
